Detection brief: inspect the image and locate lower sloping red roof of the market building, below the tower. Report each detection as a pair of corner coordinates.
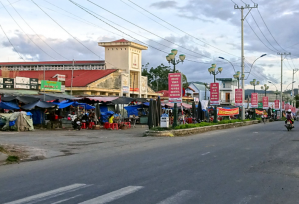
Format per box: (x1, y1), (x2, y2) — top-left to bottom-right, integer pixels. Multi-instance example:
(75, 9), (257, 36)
(0, 69), (117, 87)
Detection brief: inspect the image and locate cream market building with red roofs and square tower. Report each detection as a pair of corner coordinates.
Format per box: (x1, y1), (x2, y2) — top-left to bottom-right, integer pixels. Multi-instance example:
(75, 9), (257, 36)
(0, 39), (161, 98)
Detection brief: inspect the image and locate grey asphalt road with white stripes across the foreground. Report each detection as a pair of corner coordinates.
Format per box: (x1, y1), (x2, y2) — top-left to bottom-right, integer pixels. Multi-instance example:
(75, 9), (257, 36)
(0, 122), (299, 204)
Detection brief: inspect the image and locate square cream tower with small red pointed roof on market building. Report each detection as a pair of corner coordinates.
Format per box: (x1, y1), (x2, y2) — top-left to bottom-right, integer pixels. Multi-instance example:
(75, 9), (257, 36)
(98, 39), (147, 98)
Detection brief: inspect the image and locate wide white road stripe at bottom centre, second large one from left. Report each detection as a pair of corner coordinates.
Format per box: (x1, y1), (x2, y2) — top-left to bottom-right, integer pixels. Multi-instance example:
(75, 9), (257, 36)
(79, 186), (143, 204)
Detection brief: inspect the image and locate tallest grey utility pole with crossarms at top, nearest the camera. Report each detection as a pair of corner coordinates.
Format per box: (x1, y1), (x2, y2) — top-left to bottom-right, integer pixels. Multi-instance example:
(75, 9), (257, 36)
(234, 3), (258, 120)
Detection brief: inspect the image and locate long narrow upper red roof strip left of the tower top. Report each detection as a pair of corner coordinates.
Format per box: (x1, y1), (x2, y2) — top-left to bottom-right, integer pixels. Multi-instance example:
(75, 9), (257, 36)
(0, 60), (105, 66)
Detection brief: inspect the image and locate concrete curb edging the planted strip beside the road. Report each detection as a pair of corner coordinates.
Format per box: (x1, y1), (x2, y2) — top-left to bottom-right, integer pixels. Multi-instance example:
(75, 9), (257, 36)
(145, 120), (259, 137)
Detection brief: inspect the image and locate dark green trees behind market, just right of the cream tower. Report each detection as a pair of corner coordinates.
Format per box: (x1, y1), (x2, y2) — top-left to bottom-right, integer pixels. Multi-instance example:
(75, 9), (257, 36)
(141, 63), (188, 91)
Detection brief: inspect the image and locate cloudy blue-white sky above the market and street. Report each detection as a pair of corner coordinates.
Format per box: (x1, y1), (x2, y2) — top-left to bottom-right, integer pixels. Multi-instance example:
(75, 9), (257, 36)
(0, 0), (299, 90)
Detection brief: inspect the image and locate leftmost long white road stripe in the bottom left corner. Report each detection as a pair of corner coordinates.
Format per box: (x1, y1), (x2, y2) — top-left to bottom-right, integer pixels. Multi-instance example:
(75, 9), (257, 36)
(4, 183), (87, 204)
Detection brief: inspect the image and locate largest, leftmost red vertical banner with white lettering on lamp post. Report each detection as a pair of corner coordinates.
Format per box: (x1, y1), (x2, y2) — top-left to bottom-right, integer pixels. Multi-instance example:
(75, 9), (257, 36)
(168, 73), (183, 103)
